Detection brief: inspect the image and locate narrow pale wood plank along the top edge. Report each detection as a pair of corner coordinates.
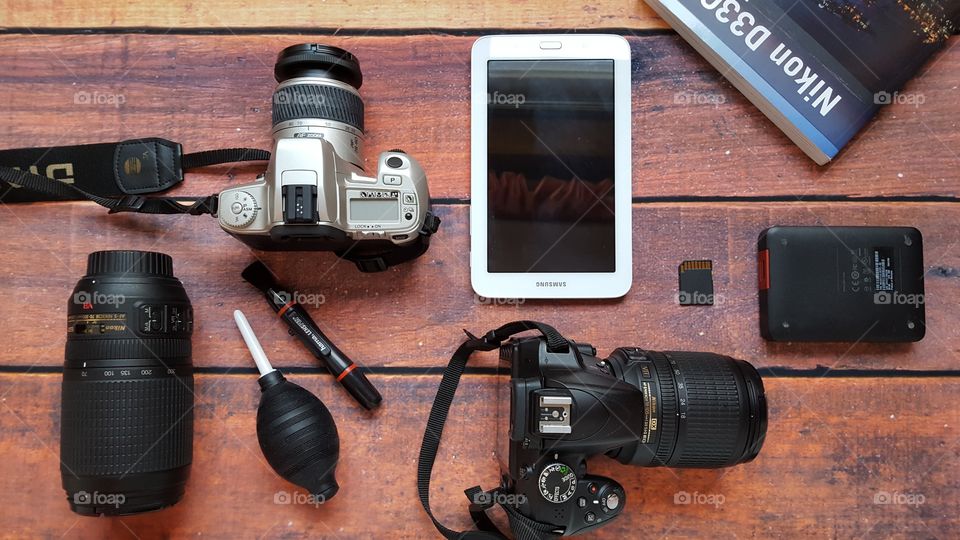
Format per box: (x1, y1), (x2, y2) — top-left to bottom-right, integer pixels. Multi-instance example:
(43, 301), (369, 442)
(0, 0), (666, 31)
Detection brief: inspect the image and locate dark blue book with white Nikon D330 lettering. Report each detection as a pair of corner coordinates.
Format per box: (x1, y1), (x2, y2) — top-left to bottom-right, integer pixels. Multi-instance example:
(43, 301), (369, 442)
(647, 0), (960, 165)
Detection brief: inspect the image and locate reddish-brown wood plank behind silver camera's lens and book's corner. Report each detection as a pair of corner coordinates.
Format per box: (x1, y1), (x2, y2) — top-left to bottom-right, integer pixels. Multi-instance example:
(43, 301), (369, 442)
(0, 33), (960, 200)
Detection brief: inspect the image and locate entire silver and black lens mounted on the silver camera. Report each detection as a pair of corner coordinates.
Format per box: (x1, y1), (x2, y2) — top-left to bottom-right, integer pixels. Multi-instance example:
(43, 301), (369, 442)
(273, 43), (363, 169)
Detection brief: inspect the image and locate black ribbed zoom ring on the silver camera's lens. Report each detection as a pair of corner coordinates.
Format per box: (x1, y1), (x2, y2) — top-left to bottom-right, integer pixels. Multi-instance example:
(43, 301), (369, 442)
(273, 84), (363, 131)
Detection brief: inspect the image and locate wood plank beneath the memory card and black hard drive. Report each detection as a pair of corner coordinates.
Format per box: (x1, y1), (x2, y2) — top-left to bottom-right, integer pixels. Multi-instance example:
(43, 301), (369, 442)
(0, 203), (960, 370)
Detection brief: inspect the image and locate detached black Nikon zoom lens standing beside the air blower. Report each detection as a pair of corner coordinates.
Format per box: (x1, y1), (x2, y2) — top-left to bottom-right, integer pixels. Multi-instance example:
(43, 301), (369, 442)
(60, 251), (194, 515)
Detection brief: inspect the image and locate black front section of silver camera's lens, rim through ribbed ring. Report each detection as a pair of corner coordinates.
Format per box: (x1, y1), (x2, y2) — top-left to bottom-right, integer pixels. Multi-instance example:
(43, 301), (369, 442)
(273, 43), (363, 132)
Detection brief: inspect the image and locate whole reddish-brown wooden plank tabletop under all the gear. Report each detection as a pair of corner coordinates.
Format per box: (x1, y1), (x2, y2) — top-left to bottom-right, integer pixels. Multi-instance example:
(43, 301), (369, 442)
(0, 0), (960, 538)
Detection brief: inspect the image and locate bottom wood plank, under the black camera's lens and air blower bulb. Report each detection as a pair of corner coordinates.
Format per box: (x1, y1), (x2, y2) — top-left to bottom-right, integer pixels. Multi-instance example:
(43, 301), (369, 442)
(0, 374), (960, 539)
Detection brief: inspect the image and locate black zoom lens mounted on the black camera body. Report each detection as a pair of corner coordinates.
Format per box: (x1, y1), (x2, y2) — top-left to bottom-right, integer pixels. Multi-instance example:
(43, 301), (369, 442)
(608, 348), (767, 468)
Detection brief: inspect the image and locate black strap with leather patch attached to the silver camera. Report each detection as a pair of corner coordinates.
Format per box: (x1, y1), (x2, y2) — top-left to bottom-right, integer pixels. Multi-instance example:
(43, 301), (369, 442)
(0, 138), (270, 215)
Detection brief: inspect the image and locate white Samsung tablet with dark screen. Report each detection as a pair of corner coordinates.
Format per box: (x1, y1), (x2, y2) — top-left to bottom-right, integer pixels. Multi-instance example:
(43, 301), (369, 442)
(470, 35), (633, 298)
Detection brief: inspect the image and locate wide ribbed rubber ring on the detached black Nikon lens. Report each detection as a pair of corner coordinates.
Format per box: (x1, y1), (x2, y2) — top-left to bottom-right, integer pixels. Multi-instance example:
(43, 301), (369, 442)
(60, 376), (193, 476)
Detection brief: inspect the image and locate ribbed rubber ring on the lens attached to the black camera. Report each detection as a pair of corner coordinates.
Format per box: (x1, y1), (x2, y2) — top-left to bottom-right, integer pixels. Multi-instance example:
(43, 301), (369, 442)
(668, 352), (745, 467)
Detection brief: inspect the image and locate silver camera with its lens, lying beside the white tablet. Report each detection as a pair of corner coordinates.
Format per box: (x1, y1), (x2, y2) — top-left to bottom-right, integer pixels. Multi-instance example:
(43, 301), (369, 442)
(218, 44), (440, 272)
